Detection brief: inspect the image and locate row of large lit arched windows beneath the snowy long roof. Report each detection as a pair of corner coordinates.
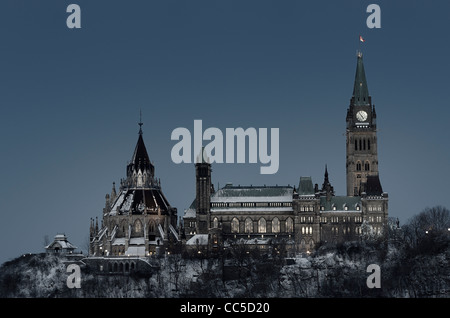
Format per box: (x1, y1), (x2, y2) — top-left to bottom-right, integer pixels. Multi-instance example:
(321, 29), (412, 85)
(229, 217), (294, 233)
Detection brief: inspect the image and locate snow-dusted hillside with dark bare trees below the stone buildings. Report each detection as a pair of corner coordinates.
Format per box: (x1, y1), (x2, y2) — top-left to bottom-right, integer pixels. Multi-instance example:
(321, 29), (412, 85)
(0, 240), (450, 298)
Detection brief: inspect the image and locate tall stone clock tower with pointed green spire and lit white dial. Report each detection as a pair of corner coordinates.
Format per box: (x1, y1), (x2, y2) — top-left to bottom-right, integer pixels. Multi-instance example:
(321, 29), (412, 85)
(346, 52), (378, 196)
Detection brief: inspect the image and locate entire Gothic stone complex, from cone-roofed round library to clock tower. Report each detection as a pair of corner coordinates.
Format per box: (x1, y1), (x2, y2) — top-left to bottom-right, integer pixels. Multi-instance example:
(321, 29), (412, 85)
(89, 53), (388, 256)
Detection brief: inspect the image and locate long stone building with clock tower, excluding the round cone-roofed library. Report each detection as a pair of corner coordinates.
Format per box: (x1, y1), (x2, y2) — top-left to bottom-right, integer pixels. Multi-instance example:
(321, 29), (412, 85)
(183, 53), (388, 254)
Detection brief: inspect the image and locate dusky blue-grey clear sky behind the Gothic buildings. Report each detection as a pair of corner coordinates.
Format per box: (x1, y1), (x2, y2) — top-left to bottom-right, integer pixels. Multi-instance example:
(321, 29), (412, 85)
(0, 0), (450, 262)
